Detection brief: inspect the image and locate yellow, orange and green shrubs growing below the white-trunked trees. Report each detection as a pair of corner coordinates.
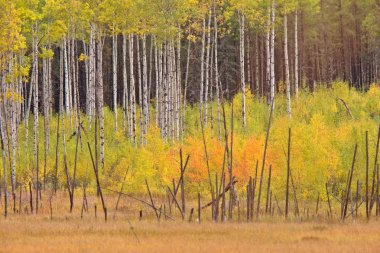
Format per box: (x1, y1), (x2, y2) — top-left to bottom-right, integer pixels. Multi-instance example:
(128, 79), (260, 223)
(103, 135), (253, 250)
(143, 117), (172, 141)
(12, 82), (380, 200)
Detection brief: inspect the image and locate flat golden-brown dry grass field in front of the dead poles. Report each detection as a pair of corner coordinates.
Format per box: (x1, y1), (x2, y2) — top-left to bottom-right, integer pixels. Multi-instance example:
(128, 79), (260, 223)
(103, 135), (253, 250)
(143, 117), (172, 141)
(0, 193), (380, 253)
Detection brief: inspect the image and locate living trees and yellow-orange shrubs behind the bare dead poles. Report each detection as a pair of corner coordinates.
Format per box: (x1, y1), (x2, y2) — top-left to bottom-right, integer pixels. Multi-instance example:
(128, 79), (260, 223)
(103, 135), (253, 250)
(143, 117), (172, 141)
(0, 0), (380, 202)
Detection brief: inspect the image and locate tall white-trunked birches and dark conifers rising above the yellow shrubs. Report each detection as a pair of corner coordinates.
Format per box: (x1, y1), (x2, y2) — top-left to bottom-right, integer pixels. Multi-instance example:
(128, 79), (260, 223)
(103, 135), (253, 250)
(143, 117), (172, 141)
(0, 0), (380, 202)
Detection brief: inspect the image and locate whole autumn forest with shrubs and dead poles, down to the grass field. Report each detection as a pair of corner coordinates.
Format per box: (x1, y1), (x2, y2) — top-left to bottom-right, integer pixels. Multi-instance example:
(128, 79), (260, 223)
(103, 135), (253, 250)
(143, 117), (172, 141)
(0, 0), (380, 252)
